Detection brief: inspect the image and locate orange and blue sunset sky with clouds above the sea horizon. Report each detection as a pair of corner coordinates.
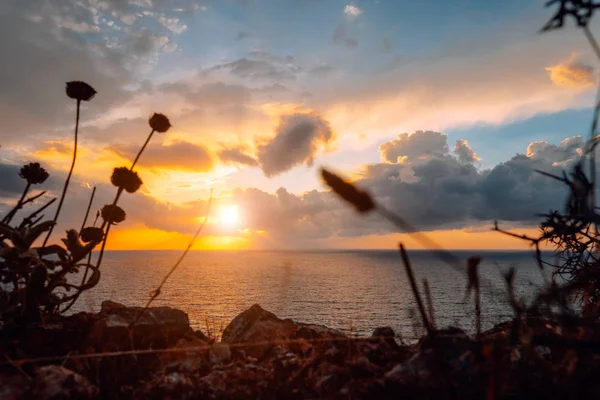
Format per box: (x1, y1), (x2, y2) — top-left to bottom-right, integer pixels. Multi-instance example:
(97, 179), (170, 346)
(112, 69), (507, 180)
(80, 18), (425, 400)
(0, 0), (600, 249)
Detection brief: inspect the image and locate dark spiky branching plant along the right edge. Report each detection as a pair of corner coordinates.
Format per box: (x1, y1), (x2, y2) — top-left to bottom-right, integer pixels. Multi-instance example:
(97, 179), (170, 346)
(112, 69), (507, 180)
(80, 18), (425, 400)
(494, 0), (600, 308)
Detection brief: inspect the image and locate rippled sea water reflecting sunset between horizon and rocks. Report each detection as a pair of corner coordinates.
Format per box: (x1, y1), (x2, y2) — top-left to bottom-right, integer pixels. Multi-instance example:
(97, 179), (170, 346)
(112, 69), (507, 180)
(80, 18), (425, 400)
(73, 251), (549, 340)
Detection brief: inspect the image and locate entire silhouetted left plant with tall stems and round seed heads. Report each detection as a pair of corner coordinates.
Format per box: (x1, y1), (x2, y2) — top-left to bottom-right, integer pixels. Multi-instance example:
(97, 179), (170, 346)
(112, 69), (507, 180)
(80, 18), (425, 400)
(0, 81), (186, 325)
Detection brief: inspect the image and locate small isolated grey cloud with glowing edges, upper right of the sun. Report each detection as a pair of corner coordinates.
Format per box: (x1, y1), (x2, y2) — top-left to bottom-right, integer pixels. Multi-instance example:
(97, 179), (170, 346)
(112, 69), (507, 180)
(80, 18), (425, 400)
(257, 113), (334, 176)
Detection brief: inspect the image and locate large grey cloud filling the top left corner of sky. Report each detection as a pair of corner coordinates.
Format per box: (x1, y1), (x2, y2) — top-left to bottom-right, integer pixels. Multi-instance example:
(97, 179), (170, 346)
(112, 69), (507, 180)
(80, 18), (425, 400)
(0, 0), (204, 145)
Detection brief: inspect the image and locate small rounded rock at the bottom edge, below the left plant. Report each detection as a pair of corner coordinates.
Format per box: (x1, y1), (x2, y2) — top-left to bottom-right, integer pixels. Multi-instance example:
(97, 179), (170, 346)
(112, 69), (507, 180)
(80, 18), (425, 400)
(33, 365), (99, 399)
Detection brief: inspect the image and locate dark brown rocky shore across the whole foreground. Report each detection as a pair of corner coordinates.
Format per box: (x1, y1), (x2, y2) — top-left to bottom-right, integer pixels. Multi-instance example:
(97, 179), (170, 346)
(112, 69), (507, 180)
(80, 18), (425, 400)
(0, 301), (600, 399)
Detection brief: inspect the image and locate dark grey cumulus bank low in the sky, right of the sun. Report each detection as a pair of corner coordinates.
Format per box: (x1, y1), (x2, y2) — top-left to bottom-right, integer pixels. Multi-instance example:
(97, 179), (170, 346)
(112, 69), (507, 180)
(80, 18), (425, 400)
(232, 131), (583, 242)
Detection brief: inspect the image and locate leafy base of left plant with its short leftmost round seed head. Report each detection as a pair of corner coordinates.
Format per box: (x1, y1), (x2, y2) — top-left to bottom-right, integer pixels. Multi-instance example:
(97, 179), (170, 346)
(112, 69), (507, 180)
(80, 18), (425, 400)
(0, 163), (99, 325)
